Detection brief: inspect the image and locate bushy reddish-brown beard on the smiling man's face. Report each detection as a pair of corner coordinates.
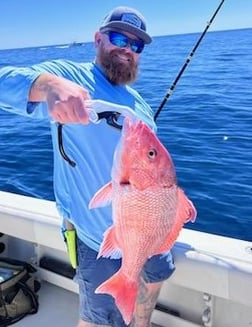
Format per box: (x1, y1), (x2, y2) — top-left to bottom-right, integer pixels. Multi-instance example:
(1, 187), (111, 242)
(97, 45), (138, 85)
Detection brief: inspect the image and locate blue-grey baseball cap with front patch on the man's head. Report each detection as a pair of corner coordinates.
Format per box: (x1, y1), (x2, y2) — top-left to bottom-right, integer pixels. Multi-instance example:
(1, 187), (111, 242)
(100, 7), (152, 44)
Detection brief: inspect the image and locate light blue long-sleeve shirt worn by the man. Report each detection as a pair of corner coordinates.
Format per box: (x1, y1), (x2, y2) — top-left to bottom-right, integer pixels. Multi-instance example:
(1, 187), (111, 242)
(0, 60), (155, 251)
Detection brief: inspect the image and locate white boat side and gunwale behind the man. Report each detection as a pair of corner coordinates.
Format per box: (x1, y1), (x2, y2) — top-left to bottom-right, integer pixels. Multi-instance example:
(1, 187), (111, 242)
(0, 192), (252, 326)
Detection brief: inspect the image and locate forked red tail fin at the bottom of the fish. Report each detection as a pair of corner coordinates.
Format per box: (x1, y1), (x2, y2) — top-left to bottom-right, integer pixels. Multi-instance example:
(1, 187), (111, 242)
(95, 270), (138, 325)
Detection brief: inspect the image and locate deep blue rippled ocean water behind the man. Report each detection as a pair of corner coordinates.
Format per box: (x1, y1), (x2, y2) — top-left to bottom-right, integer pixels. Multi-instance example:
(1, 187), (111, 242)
(0, 29), (252, 241)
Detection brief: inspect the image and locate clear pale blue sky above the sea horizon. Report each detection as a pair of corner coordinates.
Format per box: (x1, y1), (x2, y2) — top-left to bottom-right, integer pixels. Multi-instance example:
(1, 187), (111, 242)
(0, 0), (252, 49)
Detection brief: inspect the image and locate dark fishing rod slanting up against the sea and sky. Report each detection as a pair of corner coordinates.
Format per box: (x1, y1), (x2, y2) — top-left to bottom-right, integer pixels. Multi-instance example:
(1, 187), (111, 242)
(154, 0), (225, 121)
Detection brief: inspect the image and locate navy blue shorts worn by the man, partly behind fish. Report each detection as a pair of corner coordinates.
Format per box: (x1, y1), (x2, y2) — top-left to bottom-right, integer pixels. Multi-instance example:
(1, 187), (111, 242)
(76, 239), (175, 327)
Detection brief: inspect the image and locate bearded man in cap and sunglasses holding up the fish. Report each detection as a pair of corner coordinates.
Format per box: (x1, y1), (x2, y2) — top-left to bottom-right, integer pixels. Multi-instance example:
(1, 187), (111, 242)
(0, 7), (174, 327)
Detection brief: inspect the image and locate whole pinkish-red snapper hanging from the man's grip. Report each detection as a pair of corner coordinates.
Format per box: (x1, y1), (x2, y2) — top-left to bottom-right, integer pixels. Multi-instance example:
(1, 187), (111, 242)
(89, 118), (196, 324)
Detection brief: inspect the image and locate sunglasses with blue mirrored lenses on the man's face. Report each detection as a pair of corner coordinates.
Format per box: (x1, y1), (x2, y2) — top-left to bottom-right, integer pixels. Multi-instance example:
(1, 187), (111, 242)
(104, 31), (144, 53)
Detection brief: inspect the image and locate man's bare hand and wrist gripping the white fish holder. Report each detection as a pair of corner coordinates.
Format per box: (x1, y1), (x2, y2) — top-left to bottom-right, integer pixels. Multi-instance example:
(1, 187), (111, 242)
(29, 73), (90, 124)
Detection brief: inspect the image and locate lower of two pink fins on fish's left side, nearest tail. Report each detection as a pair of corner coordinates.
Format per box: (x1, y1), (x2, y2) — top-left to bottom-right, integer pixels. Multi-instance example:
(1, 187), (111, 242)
(97, 226), (122, 259)
